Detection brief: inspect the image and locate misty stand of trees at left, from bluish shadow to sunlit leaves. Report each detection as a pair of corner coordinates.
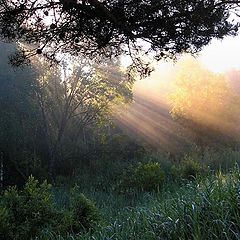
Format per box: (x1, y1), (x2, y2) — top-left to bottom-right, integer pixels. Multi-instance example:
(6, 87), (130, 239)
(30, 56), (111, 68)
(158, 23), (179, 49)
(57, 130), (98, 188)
(0, 42), (134, 186)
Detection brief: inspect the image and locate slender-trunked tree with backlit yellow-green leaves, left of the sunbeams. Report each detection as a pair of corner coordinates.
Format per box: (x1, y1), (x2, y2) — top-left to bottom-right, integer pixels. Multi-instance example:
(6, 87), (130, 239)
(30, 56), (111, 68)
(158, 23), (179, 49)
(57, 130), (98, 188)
(37, 59), (133, 181)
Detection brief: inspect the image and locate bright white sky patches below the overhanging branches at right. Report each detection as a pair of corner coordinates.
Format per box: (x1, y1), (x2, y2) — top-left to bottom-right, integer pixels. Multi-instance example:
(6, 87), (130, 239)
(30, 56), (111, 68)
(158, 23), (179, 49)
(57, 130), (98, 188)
(129, 35), (240, 95)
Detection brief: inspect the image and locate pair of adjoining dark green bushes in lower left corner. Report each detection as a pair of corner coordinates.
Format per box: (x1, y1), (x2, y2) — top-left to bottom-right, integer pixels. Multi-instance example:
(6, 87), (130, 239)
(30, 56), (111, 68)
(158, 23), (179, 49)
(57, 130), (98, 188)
(0, 177), (100, 240)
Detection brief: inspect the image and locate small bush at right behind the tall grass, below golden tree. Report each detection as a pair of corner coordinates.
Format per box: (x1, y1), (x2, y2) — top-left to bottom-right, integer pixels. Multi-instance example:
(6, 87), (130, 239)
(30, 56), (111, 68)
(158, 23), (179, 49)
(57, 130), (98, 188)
(172, 157), (207, 180)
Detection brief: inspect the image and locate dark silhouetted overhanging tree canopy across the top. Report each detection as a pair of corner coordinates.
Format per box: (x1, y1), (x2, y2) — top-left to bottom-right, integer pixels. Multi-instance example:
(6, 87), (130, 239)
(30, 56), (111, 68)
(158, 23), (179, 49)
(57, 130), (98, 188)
(0, 0), (239, 75)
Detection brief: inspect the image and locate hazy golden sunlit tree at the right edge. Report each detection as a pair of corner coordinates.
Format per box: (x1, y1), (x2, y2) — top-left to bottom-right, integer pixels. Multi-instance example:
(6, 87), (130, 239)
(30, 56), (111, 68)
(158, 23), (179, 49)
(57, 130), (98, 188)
(170, 59), (240, 147)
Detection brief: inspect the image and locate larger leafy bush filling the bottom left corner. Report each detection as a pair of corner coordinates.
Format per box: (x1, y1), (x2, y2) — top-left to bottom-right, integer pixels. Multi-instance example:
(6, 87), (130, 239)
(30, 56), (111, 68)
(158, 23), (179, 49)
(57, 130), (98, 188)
(0, 177), (57, 239)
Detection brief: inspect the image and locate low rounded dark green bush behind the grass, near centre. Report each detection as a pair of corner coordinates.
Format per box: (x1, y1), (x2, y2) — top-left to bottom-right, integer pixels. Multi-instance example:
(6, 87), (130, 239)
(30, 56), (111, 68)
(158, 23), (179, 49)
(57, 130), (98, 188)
(119, 162), (165, 192)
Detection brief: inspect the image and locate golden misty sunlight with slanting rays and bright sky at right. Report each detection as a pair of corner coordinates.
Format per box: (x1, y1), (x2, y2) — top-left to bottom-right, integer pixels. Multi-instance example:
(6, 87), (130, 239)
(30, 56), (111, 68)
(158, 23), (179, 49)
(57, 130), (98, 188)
(117, 37), (240, 152)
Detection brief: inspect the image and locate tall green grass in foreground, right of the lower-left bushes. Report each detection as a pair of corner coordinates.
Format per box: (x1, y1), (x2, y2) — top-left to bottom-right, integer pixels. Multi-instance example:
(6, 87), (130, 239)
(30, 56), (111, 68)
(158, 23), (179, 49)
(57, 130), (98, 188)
(38, 168), (240, 240)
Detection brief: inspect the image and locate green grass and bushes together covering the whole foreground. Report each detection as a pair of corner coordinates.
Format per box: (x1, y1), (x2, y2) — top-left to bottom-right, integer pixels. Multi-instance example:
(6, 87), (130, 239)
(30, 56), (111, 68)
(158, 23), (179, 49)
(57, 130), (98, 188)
(0, 151), (240, 240)
